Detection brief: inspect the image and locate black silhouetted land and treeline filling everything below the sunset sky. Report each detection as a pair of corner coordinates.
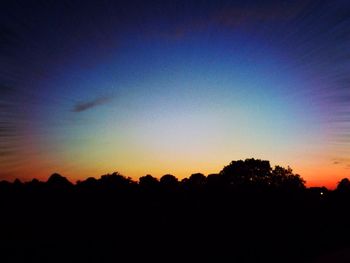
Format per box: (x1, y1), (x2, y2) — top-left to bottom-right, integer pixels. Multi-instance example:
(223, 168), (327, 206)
(0, 160), (350, 262)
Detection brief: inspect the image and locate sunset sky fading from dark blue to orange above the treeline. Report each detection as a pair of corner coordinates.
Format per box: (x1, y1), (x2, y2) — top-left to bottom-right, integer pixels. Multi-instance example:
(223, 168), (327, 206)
(0, 0), (350, 188)
